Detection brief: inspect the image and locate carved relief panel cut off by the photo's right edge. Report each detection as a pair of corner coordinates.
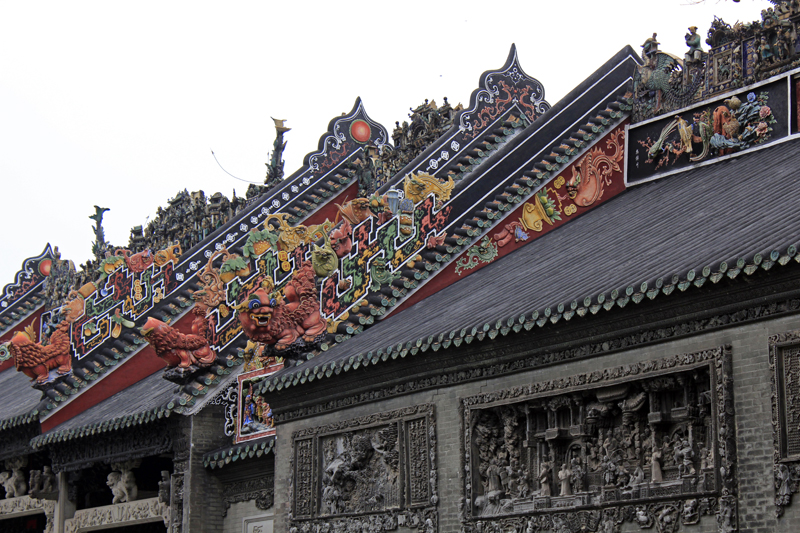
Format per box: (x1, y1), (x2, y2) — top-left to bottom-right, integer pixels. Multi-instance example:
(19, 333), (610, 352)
(769, 331), (800, 517)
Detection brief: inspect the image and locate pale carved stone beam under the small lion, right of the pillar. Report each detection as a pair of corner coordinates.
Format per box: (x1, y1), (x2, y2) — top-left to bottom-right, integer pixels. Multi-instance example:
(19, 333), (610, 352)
(64, 498), (169, 533)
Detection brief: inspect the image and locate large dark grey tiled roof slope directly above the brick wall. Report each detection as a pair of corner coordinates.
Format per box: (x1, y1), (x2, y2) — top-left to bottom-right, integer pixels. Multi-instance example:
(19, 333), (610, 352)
(260, 137), (800, 392)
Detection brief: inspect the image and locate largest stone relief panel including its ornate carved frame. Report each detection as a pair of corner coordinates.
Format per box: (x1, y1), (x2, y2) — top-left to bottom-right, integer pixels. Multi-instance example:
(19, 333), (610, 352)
(461, 347), (737, 533)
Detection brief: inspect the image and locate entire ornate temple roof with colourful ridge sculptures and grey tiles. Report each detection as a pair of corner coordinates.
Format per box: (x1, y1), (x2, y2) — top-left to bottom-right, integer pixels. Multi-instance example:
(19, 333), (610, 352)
(0, 2), (798, 482)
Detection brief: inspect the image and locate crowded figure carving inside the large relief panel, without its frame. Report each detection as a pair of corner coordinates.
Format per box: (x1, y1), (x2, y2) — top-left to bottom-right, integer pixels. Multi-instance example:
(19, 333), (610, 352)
(468, 370), (717, 523)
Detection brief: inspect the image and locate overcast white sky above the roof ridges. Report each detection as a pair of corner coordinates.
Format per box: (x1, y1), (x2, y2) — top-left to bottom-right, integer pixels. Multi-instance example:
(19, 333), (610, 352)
(0, 0), (770, 287)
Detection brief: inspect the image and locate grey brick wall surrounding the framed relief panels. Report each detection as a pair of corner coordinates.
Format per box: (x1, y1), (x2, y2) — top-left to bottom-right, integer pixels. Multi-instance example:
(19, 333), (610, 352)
(275, 316), (800, 533)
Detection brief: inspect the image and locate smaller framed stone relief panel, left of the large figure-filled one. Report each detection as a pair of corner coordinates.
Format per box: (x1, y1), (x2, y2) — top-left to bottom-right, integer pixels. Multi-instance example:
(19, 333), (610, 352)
(290, 404), (438, 533)
